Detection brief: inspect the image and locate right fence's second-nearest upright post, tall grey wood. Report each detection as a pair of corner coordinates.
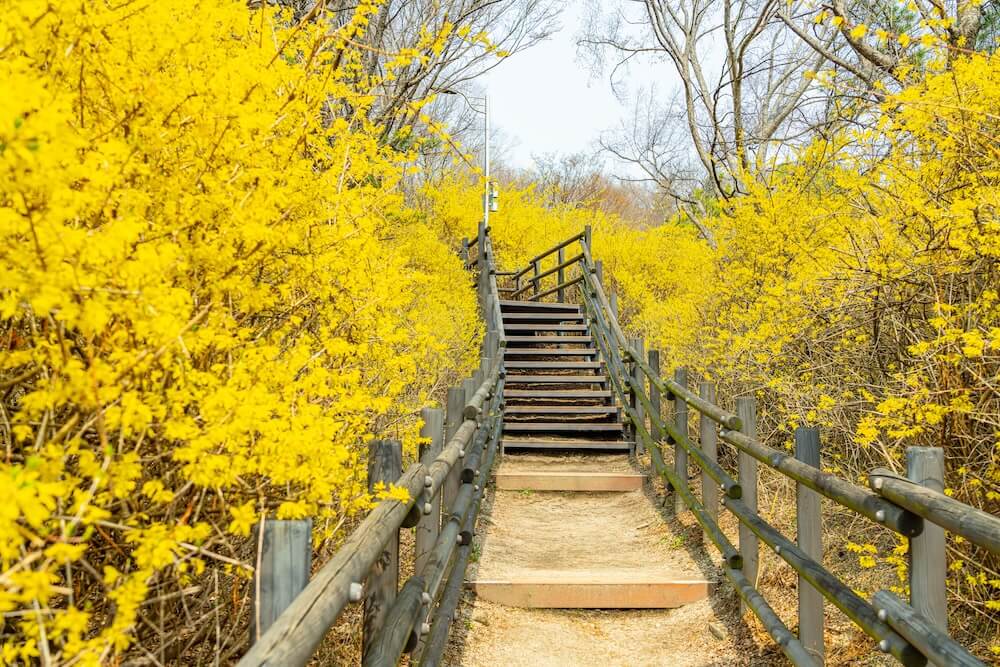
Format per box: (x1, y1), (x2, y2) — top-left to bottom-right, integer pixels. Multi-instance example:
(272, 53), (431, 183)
(795, 426), (825, 665)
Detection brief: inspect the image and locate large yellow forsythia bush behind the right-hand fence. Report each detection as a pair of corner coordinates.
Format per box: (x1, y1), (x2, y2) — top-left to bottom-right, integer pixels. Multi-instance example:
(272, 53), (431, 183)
(698, 54), (1000, 655)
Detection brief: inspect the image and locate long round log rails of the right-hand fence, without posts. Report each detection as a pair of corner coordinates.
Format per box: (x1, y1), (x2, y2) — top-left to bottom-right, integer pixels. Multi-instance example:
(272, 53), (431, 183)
(581, 232), (1000, 667)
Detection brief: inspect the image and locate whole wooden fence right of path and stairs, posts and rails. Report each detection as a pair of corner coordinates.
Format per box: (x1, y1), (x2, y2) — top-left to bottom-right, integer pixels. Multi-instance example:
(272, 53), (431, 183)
(498, 227), (1000, 667)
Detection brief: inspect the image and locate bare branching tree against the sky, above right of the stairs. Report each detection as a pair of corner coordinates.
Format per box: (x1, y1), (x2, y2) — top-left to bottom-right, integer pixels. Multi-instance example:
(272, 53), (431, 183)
(580, 0), (834, 241)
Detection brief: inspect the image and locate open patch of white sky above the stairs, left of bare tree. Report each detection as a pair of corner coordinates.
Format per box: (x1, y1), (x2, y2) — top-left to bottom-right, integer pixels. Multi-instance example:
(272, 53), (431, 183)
(481, 0), (652, 172)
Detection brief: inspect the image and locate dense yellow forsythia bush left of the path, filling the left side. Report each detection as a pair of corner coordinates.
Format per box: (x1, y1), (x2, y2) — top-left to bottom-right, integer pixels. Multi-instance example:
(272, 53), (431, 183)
(0, 0), (481, 665)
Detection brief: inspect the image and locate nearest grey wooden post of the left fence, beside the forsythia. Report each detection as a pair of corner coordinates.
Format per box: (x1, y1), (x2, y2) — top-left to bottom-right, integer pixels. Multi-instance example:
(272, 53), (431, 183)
(250, 519), (312, 644)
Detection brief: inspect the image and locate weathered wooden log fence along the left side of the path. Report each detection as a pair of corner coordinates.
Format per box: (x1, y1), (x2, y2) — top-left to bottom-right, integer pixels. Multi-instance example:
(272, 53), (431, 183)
(239, 227), (506, 667)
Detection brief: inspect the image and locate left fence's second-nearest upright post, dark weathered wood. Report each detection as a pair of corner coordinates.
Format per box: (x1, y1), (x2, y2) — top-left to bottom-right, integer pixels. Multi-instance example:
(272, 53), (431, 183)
(362, 440), (403, 655)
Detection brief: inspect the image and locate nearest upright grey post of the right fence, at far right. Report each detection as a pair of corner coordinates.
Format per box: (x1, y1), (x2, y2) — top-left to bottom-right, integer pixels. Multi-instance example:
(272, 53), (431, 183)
(906, 447), (948, 632)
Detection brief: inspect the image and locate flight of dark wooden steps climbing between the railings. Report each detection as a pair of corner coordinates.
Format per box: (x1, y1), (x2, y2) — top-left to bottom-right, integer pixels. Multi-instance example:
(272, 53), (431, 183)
(500, 301), (631, 451)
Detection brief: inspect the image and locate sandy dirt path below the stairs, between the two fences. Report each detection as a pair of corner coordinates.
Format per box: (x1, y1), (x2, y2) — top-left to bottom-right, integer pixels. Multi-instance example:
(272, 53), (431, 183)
(445, 455), (772, 667)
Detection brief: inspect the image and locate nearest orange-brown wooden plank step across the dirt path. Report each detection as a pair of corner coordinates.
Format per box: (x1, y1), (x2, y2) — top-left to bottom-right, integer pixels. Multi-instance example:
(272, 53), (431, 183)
(472, 578), (712, 609)
